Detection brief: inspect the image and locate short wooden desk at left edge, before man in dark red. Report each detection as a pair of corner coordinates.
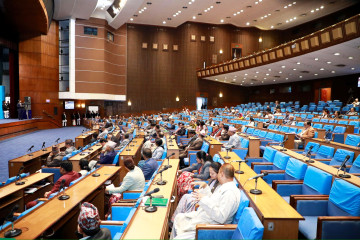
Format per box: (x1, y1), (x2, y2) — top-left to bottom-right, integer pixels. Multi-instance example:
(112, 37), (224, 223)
(0, 173), (54, 222)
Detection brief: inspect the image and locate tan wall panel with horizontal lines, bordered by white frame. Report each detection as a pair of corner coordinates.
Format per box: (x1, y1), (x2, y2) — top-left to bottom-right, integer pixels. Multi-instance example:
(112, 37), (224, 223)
(75, 18), (126, 95)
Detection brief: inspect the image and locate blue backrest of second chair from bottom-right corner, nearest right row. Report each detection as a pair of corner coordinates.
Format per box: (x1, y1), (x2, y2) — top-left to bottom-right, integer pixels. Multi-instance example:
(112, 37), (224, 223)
(302, 166), (332, 195)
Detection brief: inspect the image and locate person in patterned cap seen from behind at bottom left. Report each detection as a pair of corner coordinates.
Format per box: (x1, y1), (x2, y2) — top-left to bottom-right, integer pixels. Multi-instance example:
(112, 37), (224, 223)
(77, 202), (111, 240)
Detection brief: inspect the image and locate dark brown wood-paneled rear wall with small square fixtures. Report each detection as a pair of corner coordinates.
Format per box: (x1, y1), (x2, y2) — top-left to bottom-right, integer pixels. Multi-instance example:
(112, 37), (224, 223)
(124, 22), (280, 112)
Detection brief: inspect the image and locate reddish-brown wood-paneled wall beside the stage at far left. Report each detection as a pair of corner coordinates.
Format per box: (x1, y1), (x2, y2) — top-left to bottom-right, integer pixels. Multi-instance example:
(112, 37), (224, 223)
(18, 21), (60, 119)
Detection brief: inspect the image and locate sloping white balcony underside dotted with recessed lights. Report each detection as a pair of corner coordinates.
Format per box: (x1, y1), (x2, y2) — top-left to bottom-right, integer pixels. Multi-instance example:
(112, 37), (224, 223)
(205, 38), (360, 87)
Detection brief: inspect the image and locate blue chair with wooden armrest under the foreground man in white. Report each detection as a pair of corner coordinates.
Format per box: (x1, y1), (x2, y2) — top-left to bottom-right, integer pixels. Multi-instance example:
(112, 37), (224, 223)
(196, 207), (264, 240)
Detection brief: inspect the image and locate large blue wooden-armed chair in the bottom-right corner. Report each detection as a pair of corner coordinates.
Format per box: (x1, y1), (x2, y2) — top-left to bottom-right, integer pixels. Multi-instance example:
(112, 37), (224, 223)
(291, 179), (360, 239)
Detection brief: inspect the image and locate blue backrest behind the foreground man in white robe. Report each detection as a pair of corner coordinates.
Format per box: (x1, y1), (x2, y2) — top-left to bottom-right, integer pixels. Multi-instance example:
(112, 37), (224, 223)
(231, 207), (264, 239)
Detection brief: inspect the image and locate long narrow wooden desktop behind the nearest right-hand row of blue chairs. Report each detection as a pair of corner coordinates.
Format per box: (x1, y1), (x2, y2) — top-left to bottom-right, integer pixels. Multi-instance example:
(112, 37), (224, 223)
(272, 146), (360, 187)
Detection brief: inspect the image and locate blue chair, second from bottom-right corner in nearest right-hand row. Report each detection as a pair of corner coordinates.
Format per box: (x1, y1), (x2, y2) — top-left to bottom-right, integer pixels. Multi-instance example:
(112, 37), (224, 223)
(273, 166), (332, 201)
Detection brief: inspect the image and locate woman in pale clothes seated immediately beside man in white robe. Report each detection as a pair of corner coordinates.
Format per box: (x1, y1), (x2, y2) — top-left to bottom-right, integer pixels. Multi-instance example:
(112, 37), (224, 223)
(171, 162), (221, 222)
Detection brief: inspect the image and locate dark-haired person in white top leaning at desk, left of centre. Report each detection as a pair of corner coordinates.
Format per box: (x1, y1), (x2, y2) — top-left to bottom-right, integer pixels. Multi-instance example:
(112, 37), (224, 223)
(105, 158), (145, 209)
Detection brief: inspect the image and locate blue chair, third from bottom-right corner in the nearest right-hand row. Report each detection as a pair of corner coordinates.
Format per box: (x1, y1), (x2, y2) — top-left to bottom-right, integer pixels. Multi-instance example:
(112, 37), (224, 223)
(263, 158), (307, 184)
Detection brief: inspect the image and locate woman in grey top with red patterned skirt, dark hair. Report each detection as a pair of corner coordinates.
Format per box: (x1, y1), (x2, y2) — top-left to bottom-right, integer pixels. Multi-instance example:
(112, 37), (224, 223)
(177, 151), (212, 198)
